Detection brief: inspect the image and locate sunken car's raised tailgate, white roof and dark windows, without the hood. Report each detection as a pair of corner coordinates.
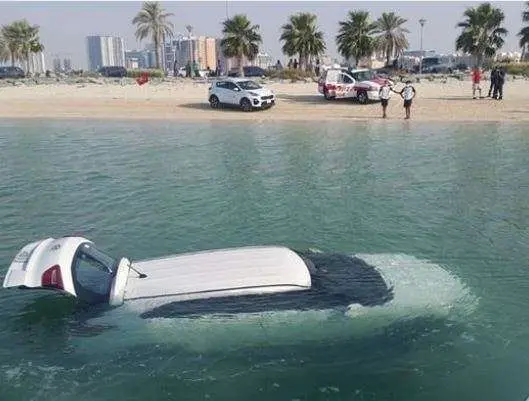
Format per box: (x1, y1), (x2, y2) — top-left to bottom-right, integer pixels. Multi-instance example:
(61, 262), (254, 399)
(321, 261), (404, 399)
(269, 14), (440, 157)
(3, 237), (393, 316)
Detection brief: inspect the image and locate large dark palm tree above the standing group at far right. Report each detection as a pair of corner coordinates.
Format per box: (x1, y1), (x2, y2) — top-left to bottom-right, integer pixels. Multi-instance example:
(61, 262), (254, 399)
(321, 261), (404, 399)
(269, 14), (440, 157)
(456, 3), (507, 67)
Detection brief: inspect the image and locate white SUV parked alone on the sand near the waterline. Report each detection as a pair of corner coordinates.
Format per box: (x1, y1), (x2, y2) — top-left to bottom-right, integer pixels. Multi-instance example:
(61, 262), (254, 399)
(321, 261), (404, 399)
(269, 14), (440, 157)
(208, 78), (276, 111)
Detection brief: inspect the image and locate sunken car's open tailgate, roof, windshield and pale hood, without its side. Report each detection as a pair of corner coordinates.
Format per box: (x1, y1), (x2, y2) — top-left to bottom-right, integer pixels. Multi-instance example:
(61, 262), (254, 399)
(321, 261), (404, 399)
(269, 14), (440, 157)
(3, 236), (468, 328)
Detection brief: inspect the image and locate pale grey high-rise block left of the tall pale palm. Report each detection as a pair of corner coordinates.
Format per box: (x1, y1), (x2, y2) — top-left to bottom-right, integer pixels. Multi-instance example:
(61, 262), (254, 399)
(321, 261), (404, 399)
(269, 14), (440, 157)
(86, 36), (125, 71)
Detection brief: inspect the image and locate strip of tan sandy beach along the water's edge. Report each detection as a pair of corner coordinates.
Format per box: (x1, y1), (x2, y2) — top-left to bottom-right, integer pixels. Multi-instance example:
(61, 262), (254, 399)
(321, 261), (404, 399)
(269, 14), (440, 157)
(0, 79), (529, 122)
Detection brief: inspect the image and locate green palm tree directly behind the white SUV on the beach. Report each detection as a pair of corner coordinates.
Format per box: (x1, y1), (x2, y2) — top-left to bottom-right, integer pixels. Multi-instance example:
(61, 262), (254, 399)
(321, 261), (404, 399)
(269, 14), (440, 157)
(220, 14), (263, 77)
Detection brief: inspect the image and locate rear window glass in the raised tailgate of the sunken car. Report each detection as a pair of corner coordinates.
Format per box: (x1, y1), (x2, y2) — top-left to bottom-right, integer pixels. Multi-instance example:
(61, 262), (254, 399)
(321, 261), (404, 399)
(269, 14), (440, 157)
(72, 242), (118, 304)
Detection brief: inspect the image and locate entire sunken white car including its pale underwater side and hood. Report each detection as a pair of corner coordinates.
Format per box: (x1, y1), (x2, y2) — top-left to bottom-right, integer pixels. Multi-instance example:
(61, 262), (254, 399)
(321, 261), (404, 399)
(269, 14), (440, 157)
(3, 237), (475, 348)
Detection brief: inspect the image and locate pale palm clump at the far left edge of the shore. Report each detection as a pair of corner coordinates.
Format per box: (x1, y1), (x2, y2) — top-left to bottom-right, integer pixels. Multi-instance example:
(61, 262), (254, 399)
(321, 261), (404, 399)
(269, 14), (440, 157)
(2, 19), (42, 72)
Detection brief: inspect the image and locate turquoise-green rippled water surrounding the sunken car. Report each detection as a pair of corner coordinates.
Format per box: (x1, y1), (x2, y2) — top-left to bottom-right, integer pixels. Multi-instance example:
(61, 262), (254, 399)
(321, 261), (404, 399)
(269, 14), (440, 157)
(0, 121), (529, 401)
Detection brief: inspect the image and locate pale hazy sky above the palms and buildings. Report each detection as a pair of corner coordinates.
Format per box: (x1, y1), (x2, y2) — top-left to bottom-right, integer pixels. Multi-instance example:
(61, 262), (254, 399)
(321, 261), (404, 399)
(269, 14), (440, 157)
(0, 0), (525, 68)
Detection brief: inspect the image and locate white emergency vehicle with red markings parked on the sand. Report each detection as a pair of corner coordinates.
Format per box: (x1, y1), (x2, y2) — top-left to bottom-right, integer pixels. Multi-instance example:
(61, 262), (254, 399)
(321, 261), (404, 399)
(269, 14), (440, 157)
(318, 68), (392, 104)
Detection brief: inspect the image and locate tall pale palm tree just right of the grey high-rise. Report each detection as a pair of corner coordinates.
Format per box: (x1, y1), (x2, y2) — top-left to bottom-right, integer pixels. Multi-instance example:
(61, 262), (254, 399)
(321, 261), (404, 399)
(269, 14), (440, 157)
(132, 1), (174, 68)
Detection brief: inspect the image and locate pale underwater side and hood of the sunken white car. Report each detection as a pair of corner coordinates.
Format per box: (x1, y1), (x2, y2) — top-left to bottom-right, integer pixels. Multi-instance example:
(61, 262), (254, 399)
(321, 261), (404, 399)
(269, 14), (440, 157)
(75, 254), (477, 351)
